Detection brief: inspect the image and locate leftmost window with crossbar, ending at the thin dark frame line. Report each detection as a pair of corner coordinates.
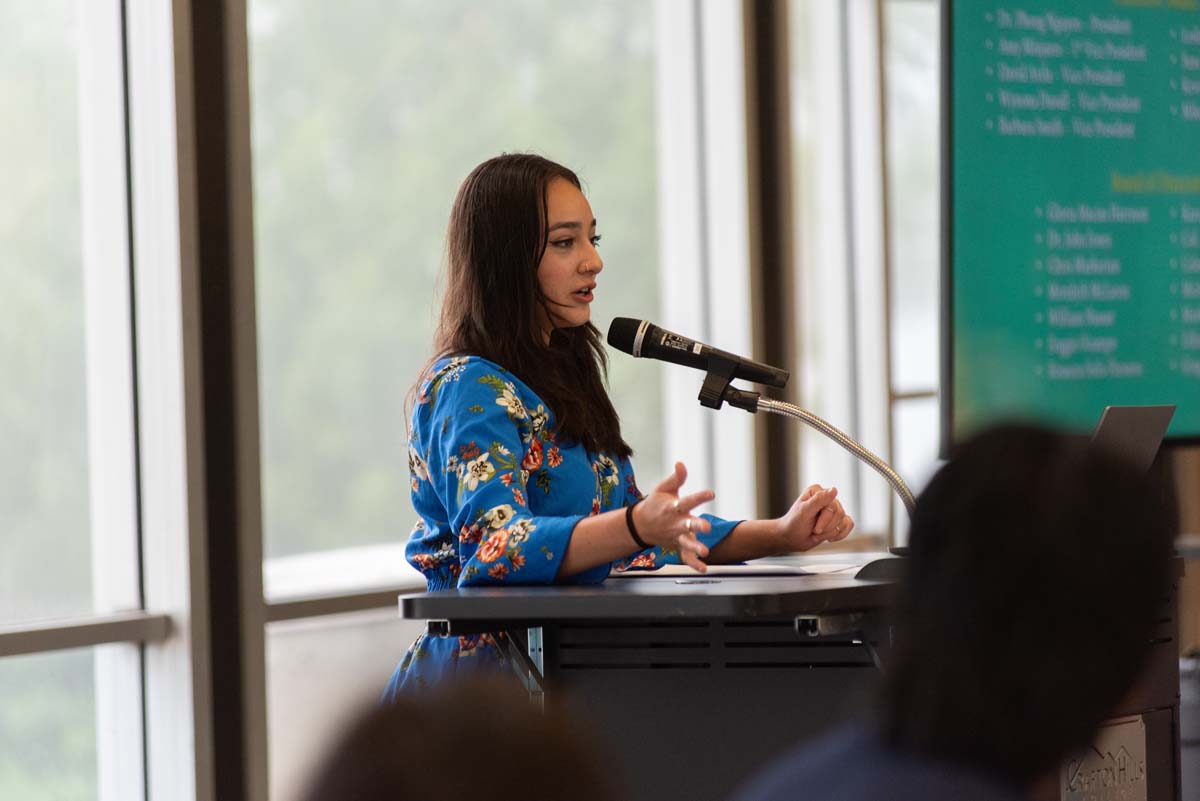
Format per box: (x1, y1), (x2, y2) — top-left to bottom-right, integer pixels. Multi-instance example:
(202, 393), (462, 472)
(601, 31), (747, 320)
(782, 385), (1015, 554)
(0, 1), (174, 799)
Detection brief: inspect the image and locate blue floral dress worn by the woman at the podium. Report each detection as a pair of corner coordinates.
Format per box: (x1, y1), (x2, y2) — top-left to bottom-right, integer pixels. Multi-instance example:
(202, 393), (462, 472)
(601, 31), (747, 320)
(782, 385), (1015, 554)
(384, 356), (738, 699)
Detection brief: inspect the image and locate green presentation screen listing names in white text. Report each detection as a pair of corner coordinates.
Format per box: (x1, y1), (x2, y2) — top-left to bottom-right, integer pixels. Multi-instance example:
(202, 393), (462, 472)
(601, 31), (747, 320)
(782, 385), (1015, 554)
(943, 0), (1200, 439)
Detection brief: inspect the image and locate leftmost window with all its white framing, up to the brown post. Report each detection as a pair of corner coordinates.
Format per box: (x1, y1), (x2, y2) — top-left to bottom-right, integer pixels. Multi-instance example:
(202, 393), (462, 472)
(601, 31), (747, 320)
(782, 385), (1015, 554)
(0, 0), (211, 801)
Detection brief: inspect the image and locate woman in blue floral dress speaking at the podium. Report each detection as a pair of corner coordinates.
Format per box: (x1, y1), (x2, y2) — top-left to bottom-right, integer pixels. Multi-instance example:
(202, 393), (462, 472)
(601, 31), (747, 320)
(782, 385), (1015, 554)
(385, 155), (854, 698)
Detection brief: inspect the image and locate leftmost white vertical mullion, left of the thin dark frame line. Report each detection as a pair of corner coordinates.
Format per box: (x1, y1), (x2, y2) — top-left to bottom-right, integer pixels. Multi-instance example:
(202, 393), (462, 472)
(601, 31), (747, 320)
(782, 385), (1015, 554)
(76, 0), (145, 801)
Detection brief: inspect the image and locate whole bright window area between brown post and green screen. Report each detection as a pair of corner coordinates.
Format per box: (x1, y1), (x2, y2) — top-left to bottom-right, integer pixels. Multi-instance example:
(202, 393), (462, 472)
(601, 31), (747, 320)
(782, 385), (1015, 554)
(788, 0), (938, 540)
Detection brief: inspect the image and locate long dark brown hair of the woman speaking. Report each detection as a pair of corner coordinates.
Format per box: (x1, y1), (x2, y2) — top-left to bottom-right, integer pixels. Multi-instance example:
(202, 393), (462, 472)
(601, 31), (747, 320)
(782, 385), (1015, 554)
(419, 153), (632, 457)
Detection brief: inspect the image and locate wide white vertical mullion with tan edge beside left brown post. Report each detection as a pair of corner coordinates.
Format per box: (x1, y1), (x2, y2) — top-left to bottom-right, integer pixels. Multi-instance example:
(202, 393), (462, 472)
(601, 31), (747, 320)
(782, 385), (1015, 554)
(125, 0), (215, 801)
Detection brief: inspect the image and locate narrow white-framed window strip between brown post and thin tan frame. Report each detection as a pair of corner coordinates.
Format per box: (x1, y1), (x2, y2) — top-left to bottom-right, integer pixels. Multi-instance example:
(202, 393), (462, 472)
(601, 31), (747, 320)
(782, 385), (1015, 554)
(788, 0), (892, 538)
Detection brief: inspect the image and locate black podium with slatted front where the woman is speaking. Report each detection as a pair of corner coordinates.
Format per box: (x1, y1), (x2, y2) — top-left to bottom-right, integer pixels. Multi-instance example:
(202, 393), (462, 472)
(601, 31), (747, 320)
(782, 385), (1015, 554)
(400, 554), (1180, 801)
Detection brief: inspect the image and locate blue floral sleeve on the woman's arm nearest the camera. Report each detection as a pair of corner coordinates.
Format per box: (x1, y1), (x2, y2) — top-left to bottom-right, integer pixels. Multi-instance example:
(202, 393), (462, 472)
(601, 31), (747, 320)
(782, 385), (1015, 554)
(426, 363), (584, 586)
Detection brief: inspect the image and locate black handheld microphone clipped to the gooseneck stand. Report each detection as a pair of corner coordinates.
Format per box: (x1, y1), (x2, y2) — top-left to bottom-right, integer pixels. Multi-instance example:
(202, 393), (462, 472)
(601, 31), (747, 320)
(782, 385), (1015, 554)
(608, 317), (792, 386)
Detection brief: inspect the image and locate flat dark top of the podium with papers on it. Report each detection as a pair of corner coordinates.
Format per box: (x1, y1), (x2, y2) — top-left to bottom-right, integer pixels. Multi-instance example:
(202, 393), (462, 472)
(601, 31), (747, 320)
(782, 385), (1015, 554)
(400, 553), (895, 622)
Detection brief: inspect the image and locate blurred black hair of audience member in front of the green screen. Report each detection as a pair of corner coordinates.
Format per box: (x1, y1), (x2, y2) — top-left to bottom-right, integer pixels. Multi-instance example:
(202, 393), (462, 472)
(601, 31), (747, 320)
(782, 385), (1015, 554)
(882, 426), (1177, 783)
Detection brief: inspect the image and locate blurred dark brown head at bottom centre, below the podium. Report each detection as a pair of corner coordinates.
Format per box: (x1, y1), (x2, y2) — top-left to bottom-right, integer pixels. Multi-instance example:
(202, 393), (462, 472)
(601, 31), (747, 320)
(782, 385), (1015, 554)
(301, 679), (616, 801)
